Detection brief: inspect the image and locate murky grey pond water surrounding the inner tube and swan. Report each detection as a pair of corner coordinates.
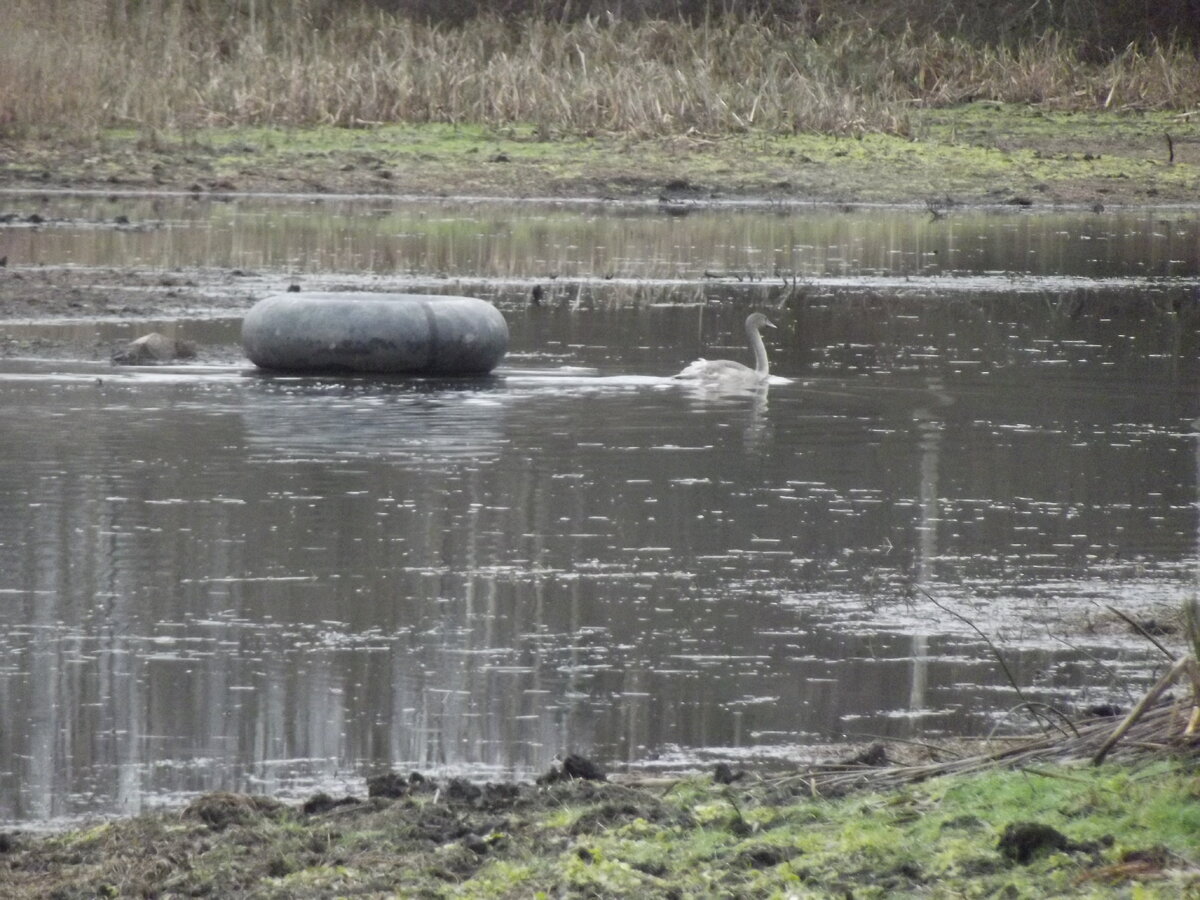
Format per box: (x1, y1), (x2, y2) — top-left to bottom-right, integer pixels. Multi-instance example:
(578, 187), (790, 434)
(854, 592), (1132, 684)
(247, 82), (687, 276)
(0, 197), (1200, 822)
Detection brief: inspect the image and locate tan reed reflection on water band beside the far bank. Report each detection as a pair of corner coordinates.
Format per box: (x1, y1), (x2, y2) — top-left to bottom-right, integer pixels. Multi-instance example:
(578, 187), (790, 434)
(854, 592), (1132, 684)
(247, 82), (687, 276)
(7, 194), (1200, 281)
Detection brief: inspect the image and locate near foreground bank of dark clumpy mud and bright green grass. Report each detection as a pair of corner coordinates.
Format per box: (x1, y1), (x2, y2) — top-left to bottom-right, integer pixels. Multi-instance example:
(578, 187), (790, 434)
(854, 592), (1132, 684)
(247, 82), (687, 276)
(0, 760), (1200, 900)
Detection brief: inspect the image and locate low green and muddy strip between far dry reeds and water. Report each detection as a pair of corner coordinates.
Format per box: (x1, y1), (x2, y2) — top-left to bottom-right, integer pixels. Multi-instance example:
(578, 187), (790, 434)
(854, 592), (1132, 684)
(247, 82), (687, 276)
(0, 103), (1200, 210)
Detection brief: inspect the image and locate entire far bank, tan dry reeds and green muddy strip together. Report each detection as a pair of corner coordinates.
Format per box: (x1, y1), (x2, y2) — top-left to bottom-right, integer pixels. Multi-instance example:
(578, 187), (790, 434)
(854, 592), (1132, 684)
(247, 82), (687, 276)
(0, 0), (1200, 206)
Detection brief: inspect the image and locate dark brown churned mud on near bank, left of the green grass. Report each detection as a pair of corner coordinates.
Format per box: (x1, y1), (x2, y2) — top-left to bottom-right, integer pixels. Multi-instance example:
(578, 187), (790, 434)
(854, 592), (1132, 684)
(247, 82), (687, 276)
(0, 774), (700, 900)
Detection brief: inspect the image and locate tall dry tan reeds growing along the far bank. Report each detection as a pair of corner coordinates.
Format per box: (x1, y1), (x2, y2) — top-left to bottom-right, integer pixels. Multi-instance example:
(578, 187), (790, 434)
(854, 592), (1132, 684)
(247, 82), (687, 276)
(0, 0), (1200, 136)
